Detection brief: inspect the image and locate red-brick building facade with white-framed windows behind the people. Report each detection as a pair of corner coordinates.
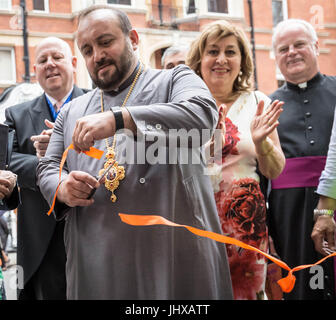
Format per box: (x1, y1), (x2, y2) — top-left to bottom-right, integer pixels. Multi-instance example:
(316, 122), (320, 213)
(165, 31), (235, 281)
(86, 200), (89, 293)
(0, 0), (336, 94)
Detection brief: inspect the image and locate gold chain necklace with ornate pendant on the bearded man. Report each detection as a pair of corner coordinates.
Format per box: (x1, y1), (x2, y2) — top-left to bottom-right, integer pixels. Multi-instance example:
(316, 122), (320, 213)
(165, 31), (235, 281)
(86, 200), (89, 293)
(99, 64), (142, 202)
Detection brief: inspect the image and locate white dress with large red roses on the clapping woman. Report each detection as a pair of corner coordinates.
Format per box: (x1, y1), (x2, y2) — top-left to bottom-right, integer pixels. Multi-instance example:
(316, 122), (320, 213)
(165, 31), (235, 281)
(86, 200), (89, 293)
(208, 91), (271, 300)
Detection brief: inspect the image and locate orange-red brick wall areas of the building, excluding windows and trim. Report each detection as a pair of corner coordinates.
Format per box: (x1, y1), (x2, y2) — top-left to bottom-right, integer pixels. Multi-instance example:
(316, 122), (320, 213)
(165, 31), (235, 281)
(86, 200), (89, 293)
(0, 0), (336, 94)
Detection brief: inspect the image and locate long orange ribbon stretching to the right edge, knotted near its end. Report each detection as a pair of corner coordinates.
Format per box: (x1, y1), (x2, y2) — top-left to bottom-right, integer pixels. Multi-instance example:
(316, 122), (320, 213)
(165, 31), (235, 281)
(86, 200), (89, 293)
(119, 213), (336, 293)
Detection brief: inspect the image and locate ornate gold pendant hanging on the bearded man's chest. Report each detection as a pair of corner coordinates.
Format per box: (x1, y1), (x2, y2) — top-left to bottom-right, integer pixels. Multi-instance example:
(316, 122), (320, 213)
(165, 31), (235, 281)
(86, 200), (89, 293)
(99, 147), (125, 202)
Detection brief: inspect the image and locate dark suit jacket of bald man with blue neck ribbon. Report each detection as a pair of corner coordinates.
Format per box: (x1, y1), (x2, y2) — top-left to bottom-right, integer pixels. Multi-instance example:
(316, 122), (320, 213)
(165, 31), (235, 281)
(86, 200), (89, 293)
(5, 86), (86, 284)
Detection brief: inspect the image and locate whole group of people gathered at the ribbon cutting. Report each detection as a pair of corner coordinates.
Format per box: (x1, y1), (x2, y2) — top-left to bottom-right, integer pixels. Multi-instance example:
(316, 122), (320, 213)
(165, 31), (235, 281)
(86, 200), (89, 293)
(0, 5), (336, 300)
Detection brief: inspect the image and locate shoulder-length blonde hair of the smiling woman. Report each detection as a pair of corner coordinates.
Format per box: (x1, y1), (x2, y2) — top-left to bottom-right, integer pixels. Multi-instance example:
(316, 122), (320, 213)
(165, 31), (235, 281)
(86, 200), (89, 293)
(186, 20), (253, 94)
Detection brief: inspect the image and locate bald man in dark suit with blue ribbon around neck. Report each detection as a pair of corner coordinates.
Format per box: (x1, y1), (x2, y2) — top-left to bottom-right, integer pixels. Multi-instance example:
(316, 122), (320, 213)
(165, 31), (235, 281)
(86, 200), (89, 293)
(5, 37), (85, 300)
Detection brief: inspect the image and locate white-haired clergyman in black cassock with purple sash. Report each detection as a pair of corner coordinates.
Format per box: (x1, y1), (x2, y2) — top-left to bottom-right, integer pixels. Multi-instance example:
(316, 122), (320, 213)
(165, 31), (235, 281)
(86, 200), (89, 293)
(268, 19), (336, 300)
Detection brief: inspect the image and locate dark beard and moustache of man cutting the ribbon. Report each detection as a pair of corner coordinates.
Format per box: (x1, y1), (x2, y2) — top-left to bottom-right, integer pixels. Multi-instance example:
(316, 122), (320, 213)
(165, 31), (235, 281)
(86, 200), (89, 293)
(90, 43), (133, 91)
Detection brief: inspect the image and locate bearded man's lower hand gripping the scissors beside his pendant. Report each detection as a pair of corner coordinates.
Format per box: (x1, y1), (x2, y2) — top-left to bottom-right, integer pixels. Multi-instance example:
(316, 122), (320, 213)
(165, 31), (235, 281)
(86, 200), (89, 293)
(57, 171), (100, 207)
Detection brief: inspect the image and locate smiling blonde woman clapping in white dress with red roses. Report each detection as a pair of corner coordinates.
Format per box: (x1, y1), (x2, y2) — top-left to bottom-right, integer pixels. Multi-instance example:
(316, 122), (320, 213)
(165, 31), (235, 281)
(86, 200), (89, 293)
(187, 21), (285, 300)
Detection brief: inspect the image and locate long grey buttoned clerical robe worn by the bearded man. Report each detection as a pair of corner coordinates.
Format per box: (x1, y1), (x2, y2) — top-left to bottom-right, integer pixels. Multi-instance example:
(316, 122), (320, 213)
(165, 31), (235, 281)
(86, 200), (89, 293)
(37, 66), (232, 299)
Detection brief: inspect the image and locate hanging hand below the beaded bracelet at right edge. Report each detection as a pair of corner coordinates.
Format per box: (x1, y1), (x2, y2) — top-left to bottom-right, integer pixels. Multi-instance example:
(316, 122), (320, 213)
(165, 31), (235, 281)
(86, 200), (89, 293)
(311, 216), (336, 256)
